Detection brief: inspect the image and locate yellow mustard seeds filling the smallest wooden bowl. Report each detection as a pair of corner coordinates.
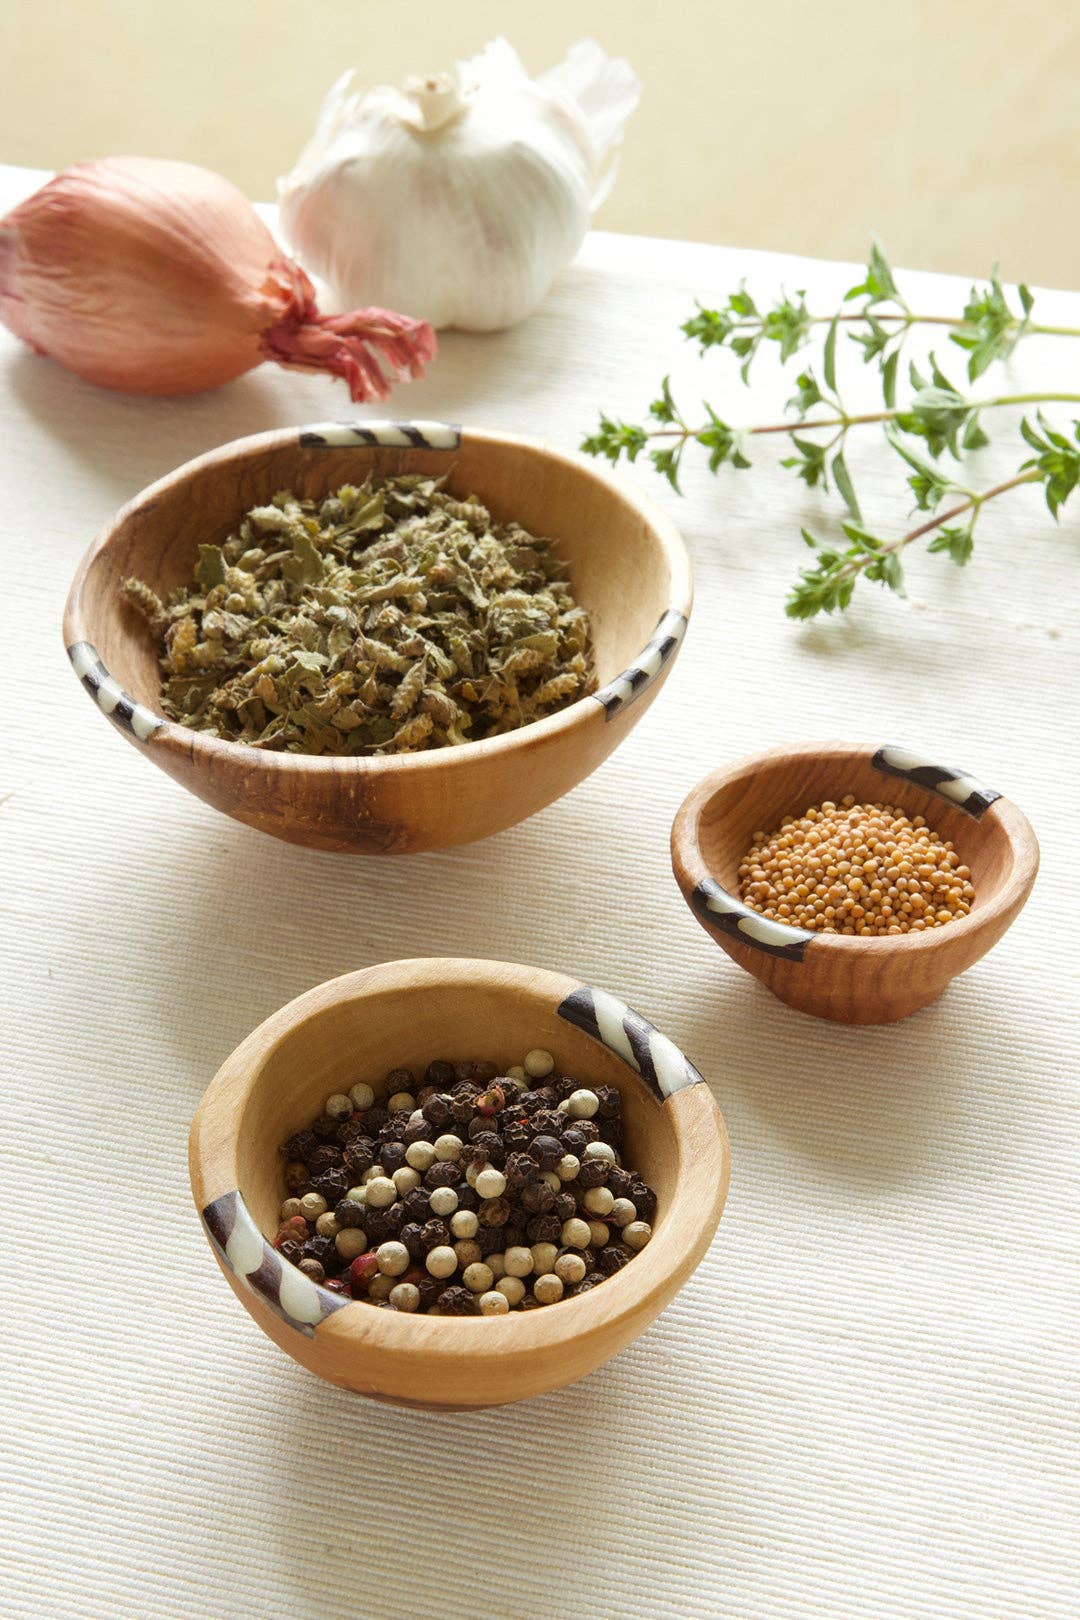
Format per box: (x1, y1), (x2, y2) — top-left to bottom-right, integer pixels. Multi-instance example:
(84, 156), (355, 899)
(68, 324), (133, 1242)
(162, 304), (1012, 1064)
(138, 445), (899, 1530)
(738, 794), (975, 936)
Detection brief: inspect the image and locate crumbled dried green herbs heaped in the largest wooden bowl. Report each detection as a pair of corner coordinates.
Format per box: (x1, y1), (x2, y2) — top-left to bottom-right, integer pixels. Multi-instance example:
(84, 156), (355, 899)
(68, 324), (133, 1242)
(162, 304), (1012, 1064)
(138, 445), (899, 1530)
(123, 476), (596, 755)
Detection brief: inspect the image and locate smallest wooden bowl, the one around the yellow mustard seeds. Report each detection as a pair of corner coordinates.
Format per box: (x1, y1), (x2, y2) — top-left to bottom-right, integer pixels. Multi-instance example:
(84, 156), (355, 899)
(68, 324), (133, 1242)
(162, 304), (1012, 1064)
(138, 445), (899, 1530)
(672, 744), (1040, 1024)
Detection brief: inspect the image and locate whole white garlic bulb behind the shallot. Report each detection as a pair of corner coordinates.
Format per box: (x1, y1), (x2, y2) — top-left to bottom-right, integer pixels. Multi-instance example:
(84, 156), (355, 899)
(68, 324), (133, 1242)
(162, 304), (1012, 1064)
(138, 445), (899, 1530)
(279, 39), (640, 332)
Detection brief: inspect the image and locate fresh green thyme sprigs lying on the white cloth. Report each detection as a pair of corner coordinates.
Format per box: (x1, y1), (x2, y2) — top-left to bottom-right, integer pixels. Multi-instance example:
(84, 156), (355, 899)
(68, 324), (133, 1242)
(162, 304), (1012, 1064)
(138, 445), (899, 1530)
(581, 241), (1080, 619)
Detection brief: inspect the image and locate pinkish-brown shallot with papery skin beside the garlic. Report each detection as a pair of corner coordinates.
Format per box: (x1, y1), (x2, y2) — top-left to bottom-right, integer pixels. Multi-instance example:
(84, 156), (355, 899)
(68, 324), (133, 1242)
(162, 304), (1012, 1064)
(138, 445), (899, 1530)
(0, 157), (436, 400)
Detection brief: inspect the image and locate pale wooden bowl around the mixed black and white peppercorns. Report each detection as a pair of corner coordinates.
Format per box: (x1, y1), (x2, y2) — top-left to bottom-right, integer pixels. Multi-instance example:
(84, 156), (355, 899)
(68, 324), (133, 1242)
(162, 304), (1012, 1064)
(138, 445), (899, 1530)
(189, 957), (729, 1411)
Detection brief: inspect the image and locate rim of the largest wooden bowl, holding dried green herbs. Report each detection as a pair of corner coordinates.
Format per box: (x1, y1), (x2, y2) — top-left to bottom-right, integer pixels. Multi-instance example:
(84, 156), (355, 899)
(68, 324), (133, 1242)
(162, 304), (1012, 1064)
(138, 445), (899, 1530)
(63, 418), (693, 776)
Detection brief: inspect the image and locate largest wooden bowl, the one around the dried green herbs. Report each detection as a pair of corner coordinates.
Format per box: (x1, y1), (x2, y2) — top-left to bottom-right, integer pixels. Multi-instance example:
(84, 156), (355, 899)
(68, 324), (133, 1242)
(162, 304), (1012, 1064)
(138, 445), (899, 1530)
(63, 421), (693, 852)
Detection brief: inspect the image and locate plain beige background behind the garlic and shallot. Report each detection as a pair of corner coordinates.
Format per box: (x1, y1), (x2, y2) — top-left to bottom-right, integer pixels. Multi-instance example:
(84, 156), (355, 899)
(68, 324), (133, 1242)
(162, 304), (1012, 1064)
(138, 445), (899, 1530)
(0, 0), (1080, 287)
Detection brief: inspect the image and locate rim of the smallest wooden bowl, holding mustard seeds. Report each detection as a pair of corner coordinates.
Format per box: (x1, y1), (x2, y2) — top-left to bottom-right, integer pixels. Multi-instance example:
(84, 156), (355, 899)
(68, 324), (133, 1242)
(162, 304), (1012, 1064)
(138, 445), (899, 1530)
(670, 742), (1040, 966)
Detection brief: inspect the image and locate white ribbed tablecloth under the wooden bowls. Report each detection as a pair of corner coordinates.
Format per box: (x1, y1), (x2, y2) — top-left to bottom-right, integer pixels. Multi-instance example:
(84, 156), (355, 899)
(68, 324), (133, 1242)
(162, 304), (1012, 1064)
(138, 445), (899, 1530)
(0, 170), (1080, 1620)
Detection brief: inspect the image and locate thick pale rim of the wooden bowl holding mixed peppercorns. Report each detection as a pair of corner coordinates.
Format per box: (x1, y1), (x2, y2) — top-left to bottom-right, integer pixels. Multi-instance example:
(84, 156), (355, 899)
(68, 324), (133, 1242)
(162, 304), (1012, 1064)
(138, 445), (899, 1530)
(188, 957), (730, 1366)
